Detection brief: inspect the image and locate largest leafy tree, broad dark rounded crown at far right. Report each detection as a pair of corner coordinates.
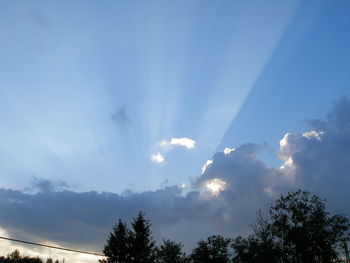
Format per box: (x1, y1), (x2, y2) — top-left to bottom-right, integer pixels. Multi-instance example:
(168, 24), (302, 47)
(270, 190), (350, 263)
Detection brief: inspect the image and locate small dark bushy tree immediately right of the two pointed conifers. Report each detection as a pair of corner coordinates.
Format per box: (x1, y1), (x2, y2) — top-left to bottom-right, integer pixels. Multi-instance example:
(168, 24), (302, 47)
(156, 240), (186, 263)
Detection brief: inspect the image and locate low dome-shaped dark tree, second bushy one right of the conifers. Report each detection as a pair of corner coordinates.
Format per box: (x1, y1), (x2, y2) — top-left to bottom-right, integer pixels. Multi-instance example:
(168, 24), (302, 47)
(190, 235), (231, 263)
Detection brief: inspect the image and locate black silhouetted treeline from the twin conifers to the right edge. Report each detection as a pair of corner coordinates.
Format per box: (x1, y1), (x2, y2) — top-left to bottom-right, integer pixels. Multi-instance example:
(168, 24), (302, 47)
(100, 190), (350, 263)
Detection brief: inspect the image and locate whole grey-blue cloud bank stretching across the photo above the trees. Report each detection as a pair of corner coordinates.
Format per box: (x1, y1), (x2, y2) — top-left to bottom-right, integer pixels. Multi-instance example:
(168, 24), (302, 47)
(0, 98), (350, 252)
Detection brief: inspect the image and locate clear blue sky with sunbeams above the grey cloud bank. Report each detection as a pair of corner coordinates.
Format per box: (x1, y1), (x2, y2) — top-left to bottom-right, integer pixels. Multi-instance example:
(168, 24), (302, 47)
(0, 0), (350, 260)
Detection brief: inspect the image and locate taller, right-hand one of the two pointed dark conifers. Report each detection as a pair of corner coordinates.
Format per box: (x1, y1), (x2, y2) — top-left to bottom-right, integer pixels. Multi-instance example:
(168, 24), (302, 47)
(129, 212), (155, 263)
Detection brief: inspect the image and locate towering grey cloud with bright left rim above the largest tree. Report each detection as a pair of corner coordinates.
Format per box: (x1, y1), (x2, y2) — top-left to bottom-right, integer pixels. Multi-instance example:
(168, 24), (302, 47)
(280, 97), (350, 212)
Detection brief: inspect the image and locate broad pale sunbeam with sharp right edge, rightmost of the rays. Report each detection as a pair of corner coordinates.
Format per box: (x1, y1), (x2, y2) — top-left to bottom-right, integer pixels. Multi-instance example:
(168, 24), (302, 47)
(199, 1), (300, 151)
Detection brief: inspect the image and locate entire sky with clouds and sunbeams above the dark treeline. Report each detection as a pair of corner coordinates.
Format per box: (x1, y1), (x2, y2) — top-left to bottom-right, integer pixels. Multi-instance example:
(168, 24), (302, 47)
(0, 0), (350, 261)
